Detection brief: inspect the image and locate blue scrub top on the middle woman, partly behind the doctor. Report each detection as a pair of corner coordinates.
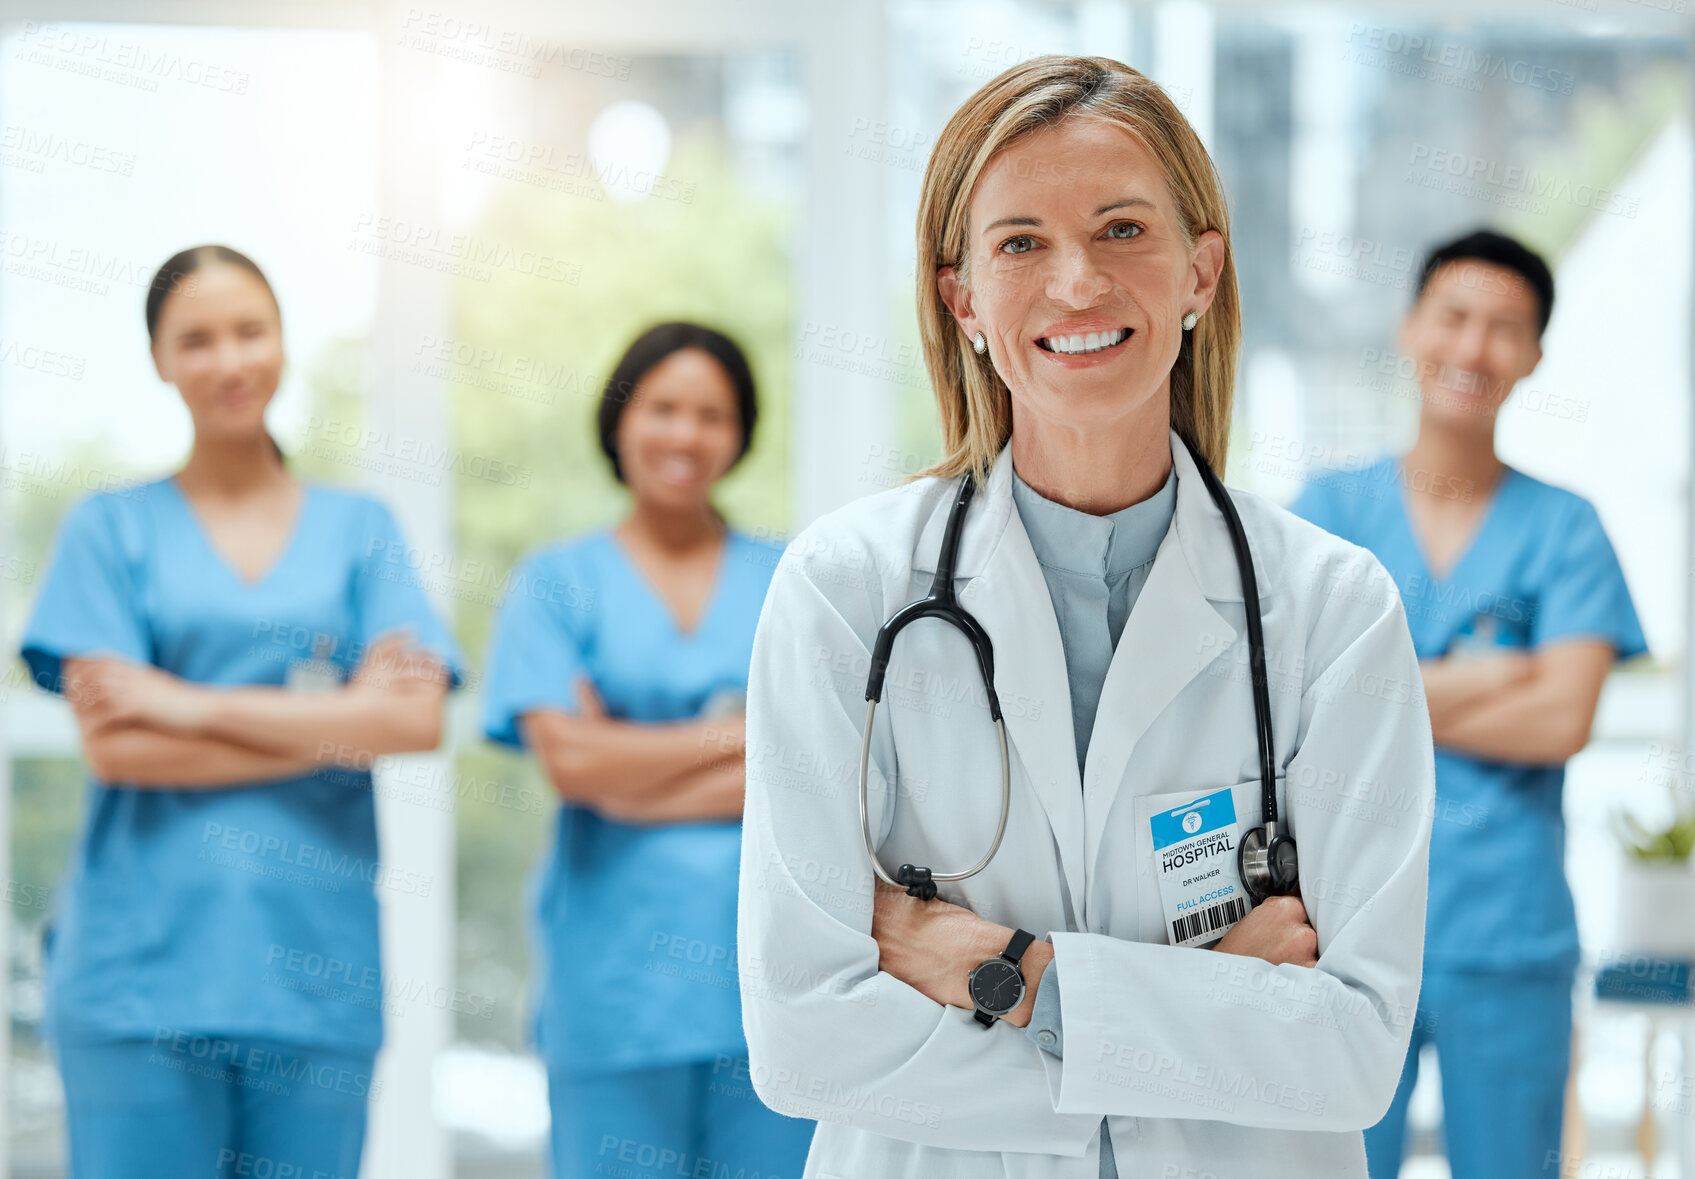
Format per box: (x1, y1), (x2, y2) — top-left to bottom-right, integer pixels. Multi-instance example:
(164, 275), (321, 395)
(483, 530), (781, 1072)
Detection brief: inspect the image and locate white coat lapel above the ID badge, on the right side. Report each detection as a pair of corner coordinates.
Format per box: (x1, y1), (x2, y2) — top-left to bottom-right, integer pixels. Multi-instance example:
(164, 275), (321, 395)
(1083, 434), (1266, 867)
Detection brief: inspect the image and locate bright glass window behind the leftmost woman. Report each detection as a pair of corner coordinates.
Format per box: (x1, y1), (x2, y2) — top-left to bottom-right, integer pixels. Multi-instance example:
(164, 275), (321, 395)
(0, 20), (378, 1176)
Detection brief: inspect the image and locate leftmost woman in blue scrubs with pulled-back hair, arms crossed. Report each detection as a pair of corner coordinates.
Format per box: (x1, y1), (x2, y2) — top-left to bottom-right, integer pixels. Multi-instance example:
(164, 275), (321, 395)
(22, 246), (458, 1179)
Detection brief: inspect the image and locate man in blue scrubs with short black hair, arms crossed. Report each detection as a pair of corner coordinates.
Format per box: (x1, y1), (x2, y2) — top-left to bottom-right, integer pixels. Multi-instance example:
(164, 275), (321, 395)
(1290, 232), (1648, 1179)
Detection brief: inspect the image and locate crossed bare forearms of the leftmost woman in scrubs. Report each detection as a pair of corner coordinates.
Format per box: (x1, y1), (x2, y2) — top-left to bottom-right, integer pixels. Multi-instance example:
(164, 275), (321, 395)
(64, 632), (447, 789)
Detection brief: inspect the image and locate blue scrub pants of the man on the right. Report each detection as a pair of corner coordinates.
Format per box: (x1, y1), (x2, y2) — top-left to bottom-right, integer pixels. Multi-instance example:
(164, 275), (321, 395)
(1366, 969), (1573, 1179)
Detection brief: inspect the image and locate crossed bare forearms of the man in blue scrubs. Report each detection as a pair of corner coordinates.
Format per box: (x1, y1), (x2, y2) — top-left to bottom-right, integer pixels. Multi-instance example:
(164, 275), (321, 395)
(1420, 639), (1615, 764)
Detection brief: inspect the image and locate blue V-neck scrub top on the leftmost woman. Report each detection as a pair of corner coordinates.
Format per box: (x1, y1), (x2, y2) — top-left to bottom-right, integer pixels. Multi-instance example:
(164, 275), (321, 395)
(22, 479), (461, 1050)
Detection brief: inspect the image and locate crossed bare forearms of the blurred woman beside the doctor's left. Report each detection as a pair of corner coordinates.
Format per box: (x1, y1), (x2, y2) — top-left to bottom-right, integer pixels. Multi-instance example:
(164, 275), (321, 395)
(520, 679), (747, 823)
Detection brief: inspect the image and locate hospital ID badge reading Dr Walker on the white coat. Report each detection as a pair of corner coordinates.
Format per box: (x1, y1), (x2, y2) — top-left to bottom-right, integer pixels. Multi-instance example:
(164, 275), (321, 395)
(1148, 786), (1249, 945)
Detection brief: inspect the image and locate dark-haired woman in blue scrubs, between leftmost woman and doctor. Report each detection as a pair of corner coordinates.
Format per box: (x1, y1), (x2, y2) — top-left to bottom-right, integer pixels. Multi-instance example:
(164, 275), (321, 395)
(483, 324), (814, 1179)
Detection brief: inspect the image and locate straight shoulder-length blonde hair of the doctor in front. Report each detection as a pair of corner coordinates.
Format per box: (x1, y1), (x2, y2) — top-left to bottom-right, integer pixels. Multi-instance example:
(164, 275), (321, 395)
(917, 56), (1242, 478)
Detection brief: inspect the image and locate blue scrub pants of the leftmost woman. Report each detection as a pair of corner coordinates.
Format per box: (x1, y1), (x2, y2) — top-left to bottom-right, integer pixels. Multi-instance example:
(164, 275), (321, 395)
(54, 1037), (373, 1179)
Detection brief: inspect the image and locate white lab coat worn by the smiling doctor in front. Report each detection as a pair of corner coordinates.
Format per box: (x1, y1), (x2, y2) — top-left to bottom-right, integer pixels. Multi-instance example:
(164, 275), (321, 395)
(737, 434), (1434, 1179)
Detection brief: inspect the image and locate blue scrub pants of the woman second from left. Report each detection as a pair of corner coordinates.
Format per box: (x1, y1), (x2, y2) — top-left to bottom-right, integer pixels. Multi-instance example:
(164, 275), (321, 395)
(547, 1057), (815, 1179)
